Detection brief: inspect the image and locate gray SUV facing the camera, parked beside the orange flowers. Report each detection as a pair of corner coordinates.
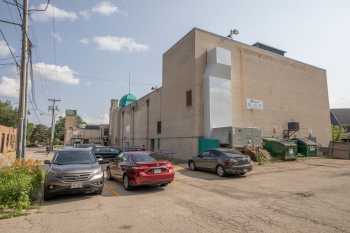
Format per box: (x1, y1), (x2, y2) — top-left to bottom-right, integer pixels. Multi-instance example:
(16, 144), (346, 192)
(44, 148), (104, 200)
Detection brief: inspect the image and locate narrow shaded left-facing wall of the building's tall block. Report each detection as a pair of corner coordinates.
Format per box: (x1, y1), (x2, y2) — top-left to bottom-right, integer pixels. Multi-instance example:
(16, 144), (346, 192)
(161, 31), (201, 158)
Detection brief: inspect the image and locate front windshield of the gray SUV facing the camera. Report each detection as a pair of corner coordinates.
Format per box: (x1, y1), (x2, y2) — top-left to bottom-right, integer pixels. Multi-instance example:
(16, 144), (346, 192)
(53, 151), (96, 165)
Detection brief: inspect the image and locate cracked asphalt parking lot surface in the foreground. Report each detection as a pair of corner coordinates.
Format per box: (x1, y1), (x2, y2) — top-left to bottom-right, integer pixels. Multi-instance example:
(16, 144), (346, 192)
(0, 158), (350, 233)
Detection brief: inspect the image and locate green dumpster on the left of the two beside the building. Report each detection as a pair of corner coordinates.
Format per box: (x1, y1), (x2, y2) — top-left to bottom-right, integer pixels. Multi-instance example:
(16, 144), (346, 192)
(263, 138), (297, 160)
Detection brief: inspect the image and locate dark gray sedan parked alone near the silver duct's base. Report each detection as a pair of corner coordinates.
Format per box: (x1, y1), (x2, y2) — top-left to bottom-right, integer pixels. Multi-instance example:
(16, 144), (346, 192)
(188, 149), (253, 176)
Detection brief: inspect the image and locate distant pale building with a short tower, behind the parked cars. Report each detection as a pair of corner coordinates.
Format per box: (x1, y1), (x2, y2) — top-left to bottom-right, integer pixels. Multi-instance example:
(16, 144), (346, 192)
(64, 110), (109, 145)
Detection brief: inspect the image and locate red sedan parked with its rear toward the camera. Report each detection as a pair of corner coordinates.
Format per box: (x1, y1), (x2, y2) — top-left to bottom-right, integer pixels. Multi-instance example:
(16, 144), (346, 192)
(106, 151), (175, 190)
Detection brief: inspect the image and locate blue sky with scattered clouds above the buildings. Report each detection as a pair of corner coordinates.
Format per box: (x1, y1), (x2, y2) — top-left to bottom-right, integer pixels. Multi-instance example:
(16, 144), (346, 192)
(0, 0), (350, 124)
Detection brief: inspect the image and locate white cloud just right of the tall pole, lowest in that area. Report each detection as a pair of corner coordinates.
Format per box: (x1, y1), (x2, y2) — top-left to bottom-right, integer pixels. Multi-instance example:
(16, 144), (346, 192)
(33, 62), (79, 85)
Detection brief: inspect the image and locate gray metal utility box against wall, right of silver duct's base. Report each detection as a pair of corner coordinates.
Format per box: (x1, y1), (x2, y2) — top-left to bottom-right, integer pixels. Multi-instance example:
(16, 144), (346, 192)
(232, 128), (262, 147)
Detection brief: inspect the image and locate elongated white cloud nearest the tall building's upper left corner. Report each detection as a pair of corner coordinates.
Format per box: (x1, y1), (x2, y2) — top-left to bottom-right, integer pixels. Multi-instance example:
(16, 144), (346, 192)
(92, 36), (148, 52)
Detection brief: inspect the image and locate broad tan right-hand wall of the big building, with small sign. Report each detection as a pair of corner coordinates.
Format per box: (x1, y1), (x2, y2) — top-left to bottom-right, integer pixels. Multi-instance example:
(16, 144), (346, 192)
(196, 30), (331, 146)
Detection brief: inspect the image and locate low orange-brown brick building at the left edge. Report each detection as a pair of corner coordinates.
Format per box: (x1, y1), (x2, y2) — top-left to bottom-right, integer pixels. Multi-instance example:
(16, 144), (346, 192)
(0, 125), (16, 153)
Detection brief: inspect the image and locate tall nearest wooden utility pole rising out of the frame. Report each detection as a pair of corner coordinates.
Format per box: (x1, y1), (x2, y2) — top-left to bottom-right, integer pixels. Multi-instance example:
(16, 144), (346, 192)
(16, 0), (28, 159)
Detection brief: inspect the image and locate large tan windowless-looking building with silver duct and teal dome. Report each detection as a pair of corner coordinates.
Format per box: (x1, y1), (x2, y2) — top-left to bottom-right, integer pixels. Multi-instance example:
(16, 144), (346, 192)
(109, 28), (331, 159)
